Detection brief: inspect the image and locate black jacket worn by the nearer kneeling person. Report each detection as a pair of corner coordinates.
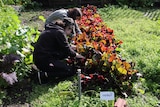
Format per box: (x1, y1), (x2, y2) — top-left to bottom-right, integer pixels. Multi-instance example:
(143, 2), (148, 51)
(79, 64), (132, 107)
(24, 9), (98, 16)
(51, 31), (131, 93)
(33, 23), (76, 64)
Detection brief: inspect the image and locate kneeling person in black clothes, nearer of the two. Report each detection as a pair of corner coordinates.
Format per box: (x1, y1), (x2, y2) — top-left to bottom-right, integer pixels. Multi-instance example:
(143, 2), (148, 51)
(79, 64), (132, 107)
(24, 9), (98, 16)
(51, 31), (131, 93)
(33, 18), (84, 83)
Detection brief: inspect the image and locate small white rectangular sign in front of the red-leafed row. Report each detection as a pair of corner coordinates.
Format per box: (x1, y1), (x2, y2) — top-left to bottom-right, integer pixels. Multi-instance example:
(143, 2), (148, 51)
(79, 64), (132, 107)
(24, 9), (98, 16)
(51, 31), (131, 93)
(100, 91), (115, 100)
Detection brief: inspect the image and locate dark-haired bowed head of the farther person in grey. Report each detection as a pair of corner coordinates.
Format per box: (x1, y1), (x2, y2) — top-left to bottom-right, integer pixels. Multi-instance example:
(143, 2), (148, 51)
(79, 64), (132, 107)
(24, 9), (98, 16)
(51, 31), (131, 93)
(68, 7), (82, 20)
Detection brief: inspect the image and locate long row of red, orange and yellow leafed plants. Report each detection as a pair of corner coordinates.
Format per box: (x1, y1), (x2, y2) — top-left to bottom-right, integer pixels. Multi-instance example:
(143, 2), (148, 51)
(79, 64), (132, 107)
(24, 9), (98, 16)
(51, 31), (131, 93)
(73, 5), (137, 95)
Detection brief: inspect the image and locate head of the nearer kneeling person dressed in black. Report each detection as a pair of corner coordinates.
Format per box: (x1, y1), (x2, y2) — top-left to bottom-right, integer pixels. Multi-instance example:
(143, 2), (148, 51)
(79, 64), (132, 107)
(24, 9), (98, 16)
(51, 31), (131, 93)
(55, 18), (74, 35)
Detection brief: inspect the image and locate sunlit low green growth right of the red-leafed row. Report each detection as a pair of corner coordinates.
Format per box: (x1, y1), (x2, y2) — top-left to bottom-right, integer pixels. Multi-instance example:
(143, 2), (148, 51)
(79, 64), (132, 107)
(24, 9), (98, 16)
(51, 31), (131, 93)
(99, 6), (160, 107)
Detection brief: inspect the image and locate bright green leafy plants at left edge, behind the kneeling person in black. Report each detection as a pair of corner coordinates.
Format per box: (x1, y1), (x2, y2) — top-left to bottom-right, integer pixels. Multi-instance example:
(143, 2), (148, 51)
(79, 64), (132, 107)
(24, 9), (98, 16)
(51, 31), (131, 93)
(0, 6), (39, 76)
